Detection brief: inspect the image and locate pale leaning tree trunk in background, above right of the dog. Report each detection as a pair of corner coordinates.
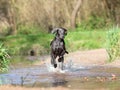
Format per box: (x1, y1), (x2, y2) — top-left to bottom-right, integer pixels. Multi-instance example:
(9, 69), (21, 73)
(71, 0), (82, 29)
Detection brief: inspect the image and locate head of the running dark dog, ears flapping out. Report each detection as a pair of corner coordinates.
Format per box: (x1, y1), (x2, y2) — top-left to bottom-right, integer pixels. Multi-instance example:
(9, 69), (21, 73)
(52, 28), (67, 39)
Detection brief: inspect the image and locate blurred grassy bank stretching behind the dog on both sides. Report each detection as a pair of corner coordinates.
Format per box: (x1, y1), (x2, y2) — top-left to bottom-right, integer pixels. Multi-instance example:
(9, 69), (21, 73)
(1, 30), (106, 55)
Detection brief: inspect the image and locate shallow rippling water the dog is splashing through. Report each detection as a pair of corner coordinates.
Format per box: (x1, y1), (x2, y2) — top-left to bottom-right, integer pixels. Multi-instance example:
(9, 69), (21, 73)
(0, 56), (120, 90)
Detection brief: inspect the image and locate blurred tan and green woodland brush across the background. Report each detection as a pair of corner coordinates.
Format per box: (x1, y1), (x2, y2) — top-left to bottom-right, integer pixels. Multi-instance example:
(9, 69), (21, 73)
(0, 0), (120, 34)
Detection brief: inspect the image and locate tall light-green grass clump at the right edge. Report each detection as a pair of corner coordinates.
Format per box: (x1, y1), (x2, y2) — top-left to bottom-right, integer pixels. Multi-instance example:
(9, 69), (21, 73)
(106, 27), (120, 62)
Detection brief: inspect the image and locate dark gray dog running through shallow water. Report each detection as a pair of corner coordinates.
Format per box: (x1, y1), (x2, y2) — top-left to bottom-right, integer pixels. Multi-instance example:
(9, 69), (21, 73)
(50, 28), (68, 70)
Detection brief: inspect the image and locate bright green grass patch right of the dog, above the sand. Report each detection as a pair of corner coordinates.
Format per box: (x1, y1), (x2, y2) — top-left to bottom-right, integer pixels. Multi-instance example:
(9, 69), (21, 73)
(65, 30), (106, 51)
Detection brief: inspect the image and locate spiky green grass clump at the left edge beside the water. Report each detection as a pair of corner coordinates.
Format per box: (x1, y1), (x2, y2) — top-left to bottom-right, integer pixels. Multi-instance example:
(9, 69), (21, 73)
(0, 44), (9, 72)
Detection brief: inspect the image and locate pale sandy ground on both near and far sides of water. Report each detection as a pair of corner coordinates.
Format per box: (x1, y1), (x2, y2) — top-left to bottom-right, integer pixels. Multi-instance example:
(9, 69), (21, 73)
(0, 49), (120, 90)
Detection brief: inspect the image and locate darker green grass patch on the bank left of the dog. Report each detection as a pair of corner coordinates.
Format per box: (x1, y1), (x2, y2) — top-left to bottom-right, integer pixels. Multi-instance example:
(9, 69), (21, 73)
(4, 33), (51, 55)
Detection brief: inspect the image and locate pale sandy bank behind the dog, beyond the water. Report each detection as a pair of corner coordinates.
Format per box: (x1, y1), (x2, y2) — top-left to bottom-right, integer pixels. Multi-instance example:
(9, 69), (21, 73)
(42, 48), (120, 67)
